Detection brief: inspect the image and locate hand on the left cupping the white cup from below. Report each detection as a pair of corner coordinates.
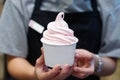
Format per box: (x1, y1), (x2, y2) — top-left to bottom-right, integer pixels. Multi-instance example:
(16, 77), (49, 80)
(35, 47), (72, 80)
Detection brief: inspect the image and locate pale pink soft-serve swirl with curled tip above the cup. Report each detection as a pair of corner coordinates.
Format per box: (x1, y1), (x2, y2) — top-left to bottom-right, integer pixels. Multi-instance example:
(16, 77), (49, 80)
(41, 12), (78, 45)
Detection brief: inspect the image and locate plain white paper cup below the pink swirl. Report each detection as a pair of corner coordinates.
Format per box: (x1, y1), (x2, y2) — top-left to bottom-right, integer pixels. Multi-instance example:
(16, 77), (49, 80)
(43, 43), (76, 67)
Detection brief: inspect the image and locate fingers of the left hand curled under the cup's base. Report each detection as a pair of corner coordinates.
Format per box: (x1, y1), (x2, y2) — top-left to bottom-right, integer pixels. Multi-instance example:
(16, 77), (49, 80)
(39, 64), (72, 80)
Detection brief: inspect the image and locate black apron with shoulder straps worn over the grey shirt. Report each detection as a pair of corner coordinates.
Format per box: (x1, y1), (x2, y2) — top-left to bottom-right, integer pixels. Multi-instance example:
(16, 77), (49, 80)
(5, 0), (102, 80)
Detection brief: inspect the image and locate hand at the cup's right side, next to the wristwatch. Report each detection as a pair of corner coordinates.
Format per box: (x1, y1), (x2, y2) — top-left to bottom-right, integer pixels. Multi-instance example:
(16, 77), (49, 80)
(72, 49), (95, 78)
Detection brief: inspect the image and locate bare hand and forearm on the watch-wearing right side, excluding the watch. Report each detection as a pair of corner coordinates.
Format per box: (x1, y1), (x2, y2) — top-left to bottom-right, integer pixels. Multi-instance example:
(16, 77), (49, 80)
(73, 49), (117, 78)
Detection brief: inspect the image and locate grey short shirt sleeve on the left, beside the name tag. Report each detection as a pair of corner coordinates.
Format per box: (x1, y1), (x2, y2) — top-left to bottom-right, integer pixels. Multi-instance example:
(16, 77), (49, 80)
(0, 0), (28, 57)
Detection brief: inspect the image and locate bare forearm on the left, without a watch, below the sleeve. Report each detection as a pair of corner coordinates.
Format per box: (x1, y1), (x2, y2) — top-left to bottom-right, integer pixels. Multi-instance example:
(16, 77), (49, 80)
(7, 56), (36, 80)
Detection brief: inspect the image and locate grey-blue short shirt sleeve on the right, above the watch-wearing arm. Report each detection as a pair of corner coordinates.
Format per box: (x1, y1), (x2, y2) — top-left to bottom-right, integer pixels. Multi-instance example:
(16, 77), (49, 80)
(98, 0), (120, 58)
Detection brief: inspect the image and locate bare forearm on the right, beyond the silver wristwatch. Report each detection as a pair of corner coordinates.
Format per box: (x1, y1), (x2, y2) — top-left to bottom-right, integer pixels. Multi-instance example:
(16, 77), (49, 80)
(94, 57), (117, 76)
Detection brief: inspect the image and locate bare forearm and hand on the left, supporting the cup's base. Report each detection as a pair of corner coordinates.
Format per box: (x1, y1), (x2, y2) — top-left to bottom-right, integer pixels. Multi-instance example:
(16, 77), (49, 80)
(7, 47), (73, 80)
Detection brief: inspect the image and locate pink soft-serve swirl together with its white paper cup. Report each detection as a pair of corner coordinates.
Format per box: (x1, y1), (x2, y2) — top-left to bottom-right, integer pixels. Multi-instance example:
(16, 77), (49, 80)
(41, 12), (78, 67)
